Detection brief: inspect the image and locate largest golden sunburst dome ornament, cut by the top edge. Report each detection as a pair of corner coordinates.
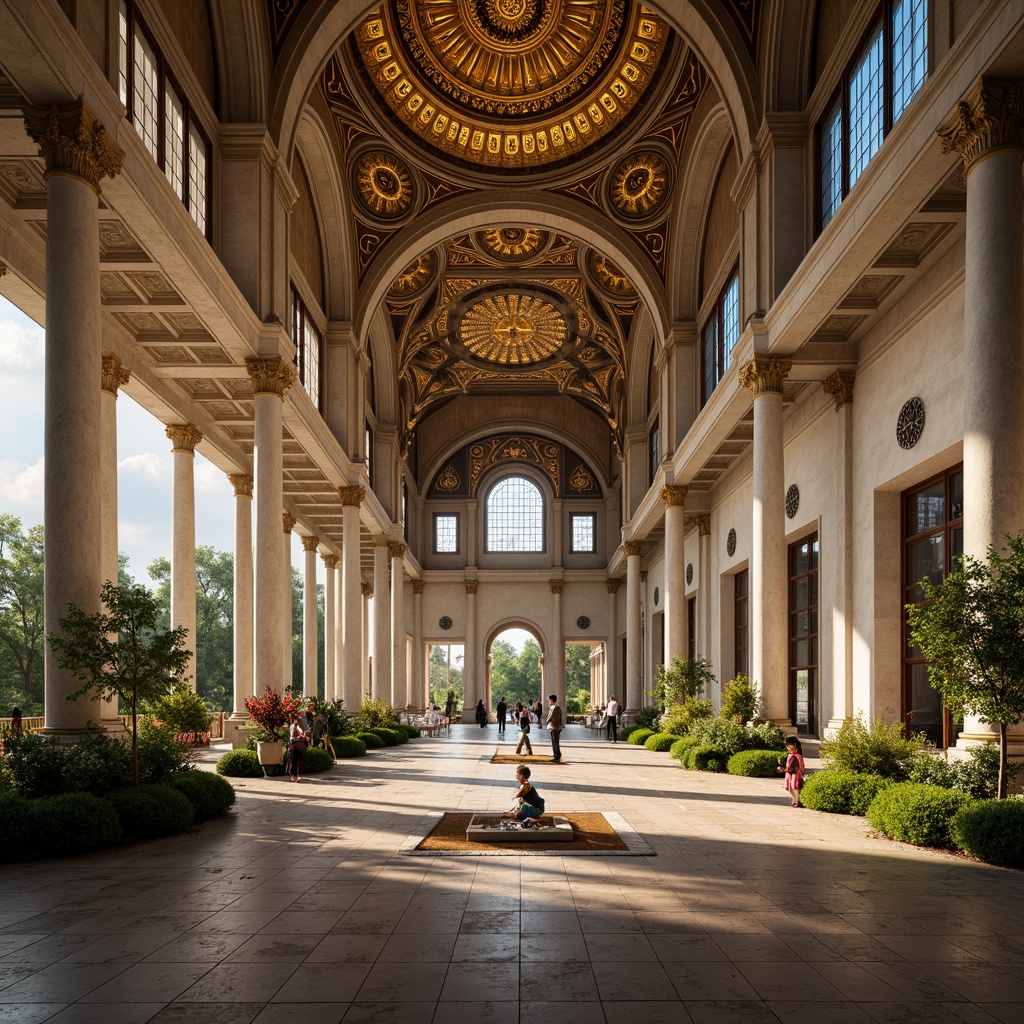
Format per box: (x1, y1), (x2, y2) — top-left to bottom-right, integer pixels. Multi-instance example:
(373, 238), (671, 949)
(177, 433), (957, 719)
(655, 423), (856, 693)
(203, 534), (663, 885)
(352, 0), (672, 171)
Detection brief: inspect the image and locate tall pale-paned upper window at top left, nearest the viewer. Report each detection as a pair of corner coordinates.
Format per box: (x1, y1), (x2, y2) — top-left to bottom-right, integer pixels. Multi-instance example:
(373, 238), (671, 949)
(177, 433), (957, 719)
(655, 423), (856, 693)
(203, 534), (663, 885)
(118, 0), (210, 236)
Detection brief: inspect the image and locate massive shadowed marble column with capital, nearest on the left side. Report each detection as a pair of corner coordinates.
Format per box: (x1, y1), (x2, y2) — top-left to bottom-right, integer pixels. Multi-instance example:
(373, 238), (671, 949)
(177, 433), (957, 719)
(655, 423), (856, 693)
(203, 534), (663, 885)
(25, 100), (124, 736)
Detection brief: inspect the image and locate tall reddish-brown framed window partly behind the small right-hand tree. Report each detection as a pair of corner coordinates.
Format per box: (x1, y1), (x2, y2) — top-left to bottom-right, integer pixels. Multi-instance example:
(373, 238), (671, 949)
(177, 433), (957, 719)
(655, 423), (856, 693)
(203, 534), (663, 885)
(902, 466), (964, 746)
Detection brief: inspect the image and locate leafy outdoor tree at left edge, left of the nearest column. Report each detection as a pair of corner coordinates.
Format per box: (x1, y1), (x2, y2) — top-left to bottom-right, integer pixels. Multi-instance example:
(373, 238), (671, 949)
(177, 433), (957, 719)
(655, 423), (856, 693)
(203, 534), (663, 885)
(0, 514), (43, 714)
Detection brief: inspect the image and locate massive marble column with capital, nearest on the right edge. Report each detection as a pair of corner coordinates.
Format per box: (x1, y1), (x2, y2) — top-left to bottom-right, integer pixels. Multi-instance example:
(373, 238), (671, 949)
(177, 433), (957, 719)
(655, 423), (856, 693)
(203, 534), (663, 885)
(937, 77), (1024, 754)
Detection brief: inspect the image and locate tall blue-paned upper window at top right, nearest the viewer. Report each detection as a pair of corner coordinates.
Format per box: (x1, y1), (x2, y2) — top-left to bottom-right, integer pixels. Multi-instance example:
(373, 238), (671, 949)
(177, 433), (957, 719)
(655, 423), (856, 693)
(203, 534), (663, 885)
(818, 0), (928, 227)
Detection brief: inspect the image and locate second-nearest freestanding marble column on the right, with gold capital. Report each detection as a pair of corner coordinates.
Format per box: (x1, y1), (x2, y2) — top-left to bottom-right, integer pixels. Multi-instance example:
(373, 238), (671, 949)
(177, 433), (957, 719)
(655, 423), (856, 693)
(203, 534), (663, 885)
(739, 354), (793, 725)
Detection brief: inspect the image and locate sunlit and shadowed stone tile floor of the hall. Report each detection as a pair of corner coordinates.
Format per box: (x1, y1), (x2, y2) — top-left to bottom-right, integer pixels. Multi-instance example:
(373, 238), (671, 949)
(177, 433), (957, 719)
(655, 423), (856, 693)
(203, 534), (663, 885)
(0, 726), (1024, 1024)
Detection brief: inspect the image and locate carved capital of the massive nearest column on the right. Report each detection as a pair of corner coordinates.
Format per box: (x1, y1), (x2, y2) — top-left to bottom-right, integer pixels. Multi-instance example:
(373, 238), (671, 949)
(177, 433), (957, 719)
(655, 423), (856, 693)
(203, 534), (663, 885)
(935, 76), (1024, 171)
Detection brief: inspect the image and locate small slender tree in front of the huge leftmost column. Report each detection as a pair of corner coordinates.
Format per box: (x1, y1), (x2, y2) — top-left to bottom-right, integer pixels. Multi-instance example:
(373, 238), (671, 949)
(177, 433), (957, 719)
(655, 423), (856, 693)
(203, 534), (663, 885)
(46, 581), (191, 785)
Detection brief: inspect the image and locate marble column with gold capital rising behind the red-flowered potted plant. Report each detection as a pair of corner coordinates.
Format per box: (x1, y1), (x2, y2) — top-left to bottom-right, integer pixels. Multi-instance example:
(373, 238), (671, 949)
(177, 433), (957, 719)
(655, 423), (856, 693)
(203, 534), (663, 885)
(246, 355), (295, 693)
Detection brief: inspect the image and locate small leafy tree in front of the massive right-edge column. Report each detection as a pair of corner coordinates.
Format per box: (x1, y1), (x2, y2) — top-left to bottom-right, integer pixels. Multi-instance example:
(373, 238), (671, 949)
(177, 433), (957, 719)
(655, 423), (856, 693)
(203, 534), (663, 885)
(907, 532), (1024, 800)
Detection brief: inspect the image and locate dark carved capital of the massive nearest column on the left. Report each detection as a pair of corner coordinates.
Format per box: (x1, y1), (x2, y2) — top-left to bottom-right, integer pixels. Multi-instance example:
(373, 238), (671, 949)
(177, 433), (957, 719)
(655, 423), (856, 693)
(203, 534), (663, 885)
(23, 97), (125, 193)
